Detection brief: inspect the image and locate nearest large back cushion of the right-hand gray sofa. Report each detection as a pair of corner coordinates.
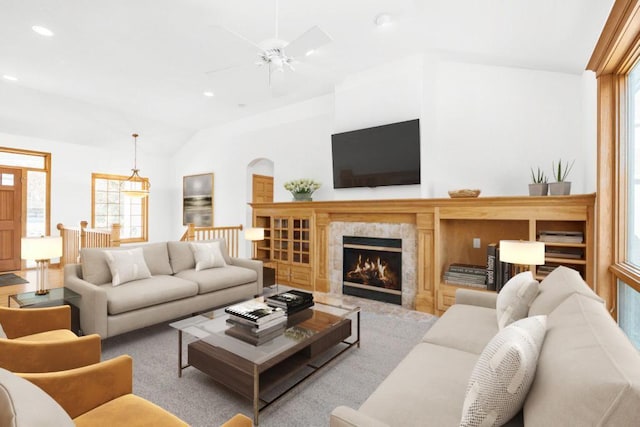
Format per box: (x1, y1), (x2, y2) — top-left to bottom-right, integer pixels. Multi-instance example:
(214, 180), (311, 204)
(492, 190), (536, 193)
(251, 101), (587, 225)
(524, 294), (640, 426)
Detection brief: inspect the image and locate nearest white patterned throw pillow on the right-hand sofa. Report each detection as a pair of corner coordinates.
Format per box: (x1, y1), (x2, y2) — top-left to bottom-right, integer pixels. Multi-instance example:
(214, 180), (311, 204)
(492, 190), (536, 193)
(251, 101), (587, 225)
(460, 316), (547, 427)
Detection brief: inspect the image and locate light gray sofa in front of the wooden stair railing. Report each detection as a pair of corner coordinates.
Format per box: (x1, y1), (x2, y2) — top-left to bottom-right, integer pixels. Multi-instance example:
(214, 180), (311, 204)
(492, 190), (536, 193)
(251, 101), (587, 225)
(64, 240), (263, 339)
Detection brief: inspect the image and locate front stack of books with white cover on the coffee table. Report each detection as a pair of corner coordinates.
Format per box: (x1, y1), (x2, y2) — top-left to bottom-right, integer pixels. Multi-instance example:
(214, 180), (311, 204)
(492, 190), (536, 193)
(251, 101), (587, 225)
(224, 301), (287, 345)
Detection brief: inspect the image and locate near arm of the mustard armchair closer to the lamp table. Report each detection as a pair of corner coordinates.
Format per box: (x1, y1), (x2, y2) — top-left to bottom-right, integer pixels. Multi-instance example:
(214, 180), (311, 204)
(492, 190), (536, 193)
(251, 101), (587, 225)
(0, 334), (102, 372)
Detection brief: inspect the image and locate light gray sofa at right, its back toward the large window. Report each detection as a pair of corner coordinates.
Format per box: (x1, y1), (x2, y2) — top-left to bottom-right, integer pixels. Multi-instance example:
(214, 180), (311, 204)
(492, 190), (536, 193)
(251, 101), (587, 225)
(330, 267), (640, 427)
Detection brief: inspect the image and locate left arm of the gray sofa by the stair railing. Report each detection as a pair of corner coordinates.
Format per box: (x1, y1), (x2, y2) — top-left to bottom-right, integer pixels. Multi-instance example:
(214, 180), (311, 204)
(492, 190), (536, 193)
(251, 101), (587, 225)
(64, 264), (107, 338)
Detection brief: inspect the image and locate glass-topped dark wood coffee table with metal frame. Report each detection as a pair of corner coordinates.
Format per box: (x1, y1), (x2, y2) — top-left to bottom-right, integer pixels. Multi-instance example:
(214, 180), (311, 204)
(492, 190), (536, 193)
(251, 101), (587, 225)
(171, 297), (360, 425)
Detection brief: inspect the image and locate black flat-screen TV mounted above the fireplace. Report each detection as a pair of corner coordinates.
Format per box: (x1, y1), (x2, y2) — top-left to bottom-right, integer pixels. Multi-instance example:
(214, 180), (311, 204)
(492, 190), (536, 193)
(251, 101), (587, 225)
(331, 119), (420, 188)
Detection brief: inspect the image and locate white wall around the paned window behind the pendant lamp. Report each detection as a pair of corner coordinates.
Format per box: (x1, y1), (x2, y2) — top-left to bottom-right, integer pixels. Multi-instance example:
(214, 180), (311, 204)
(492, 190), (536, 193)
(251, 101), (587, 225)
(0, 133), (174, 241)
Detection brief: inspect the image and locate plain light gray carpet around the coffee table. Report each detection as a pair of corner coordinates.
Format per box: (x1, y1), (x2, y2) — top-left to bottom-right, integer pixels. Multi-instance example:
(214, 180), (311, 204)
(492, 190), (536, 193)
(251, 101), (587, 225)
(103, 309), (436, 427)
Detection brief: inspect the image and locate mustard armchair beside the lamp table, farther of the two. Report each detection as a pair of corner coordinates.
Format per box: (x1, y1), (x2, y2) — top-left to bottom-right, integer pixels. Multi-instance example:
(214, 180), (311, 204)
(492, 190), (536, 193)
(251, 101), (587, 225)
(0, 305), (102, 372)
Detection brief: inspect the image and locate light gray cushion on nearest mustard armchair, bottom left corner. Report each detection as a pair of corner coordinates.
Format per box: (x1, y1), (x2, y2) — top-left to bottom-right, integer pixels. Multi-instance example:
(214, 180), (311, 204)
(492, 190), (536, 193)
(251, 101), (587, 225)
(0, 368), (75, 427)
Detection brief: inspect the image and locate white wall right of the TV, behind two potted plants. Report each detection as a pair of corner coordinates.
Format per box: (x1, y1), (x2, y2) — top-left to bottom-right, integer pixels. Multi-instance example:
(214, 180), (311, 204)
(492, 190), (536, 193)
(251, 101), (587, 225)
(424, 61), (595, 197)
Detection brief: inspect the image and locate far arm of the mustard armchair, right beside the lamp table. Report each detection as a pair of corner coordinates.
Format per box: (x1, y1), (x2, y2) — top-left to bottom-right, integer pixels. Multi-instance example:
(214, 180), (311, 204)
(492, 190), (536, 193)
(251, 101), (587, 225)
(0, 305), (71, 338)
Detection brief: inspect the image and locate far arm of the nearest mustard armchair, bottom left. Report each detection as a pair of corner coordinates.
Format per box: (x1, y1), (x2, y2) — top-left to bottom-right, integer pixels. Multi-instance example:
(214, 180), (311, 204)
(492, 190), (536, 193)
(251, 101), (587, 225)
(18, 355), (133, 418)
